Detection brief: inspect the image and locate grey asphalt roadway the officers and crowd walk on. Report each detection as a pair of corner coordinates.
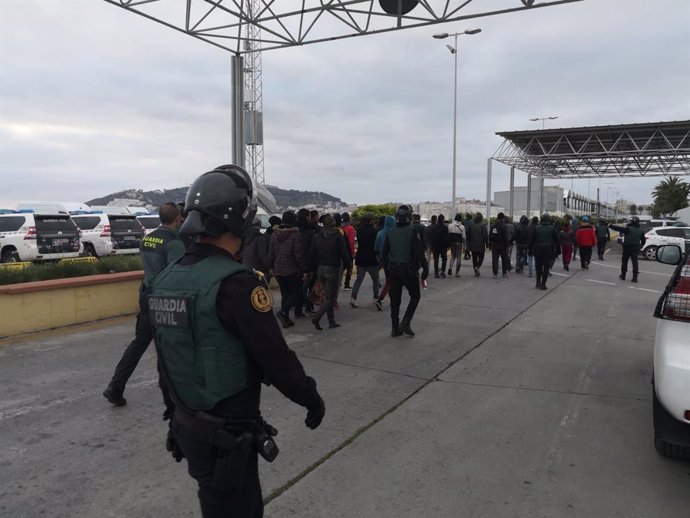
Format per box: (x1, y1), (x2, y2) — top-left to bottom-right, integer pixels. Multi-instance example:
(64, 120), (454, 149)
(0, 248), (690, 518)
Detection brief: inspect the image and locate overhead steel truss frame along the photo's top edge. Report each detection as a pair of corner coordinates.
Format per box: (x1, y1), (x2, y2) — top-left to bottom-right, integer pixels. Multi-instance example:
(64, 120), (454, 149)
(104, 0), (583, 54)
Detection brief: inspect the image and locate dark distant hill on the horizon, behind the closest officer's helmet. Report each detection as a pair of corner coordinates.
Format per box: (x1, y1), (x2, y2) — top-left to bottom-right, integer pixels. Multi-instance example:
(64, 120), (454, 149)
(86, 185), (345, 210)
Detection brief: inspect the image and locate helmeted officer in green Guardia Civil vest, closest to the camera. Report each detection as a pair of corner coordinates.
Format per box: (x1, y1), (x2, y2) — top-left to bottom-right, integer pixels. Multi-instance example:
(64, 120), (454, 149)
(149, 165), (325, 518)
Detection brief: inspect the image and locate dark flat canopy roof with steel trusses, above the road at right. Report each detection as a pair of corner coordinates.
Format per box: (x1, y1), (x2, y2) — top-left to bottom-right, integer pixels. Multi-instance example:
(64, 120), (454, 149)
(492, 121), (690, 178)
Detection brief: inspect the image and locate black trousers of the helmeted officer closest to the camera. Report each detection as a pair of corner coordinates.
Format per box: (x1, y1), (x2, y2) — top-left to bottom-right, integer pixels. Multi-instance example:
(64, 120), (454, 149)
(172, 421), (264, 518)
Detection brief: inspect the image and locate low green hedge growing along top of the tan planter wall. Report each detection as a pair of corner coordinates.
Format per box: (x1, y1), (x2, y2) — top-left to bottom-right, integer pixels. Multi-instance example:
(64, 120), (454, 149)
(0, 255), (143, 285)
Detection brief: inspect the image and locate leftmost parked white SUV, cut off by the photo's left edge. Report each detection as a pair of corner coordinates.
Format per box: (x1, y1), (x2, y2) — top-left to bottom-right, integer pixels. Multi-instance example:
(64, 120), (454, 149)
(0, 210), (83, 263)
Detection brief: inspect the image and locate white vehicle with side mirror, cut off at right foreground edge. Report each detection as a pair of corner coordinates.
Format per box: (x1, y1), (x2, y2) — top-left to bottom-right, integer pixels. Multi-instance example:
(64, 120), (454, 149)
(652, 246), (690, 458)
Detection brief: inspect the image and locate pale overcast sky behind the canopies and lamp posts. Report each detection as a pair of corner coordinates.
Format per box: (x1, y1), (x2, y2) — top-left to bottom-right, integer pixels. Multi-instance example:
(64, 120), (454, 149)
(0, 0), (690, 209)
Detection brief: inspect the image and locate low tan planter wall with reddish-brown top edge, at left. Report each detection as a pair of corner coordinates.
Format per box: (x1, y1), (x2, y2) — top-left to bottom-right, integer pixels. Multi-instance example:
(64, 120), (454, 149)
(0, 271), (144, 338)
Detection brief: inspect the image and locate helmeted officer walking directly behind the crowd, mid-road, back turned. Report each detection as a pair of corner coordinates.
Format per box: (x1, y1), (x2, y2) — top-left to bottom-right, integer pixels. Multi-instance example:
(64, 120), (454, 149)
(381, 205), (429, 337)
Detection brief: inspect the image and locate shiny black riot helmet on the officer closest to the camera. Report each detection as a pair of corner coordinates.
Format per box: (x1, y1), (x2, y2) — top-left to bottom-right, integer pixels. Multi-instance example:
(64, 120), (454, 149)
(180, 165), (256, 237)
